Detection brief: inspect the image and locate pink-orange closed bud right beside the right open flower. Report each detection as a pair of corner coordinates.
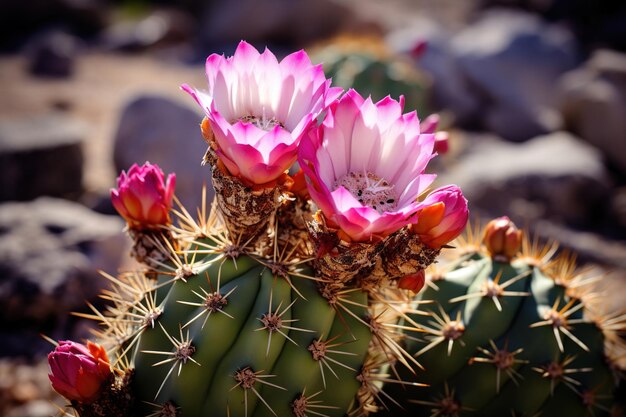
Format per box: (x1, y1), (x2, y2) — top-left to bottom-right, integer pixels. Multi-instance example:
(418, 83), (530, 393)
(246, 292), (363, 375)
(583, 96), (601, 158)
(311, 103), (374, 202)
(411, 185), (469, 249)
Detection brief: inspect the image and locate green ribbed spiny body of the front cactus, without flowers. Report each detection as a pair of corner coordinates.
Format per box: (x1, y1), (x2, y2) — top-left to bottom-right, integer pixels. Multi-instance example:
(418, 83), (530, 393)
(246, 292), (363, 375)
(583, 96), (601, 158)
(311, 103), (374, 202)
(108, 230), (371, 416)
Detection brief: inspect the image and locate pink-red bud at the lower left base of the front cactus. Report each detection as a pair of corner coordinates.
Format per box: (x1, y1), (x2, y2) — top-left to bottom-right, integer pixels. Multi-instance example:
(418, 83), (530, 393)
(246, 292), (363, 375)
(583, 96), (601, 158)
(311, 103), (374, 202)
(48, 340), (111, 404)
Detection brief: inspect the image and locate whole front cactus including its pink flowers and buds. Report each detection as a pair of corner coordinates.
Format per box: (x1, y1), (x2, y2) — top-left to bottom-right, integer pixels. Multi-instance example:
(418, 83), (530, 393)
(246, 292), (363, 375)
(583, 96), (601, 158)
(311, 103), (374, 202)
(49, 42), (468, 417)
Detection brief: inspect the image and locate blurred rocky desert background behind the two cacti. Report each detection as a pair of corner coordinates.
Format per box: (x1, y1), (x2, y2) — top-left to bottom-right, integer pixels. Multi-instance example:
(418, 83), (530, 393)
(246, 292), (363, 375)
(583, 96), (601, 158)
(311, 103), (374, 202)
(0, 0), (626, 417)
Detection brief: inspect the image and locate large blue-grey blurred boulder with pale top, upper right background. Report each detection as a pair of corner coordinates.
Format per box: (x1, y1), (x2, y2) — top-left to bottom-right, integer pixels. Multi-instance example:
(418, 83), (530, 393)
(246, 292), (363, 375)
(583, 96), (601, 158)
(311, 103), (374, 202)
(452, 10), (578, 141)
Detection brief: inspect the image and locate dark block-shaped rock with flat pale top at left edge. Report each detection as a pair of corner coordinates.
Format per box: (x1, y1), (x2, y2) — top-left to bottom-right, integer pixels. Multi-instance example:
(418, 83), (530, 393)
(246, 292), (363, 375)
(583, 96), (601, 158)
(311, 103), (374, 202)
(0, 114), (86, 201)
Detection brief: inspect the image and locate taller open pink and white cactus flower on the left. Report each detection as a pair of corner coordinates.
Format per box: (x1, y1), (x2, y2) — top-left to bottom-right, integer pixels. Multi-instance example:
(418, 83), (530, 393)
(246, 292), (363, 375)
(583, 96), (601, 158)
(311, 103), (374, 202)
(181, 41), (342, 185)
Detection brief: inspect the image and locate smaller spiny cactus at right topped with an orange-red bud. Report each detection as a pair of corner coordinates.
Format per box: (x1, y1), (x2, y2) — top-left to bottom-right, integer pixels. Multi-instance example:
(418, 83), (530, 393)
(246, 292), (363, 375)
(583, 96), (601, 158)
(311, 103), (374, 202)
(387, 218), (626, 417)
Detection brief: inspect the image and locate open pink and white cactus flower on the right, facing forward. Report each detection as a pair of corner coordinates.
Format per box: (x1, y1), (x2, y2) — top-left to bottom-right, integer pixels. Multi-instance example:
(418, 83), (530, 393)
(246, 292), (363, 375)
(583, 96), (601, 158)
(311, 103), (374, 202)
(298, 90), (435, 242)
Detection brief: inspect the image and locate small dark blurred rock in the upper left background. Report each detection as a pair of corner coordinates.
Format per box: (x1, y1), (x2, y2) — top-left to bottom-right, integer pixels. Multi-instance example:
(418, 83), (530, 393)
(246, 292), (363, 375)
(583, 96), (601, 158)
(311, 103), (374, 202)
(24, 31), (79, 78)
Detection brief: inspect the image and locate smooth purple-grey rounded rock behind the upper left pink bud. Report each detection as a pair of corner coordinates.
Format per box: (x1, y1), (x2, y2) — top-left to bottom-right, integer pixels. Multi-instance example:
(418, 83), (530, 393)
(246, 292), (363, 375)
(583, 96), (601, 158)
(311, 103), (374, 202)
(113, 96), (214, 213)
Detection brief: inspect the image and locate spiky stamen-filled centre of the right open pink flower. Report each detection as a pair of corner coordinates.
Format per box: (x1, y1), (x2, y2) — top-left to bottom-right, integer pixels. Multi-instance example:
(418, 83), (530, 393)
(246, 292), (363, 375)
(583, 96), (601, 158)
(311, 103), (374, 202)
(334, 172), (396, 214)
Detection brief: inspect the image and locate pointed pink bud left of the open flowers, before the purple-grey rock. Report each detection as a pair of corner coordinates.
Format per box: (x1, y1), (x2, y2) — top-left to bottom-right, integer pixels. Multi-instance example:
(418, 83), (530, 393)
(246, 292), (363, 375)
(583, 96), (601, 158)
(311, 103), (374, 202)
(111, 162), (176, 229)
